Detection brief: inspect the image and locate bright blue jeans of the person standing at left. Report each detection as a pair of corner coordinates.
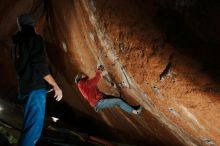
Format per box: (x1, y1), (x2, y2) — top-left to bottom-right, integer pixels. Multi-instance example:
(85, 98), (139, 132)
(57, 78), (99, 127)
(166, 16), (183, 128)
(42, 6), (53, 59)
(19, 89), (46, 146)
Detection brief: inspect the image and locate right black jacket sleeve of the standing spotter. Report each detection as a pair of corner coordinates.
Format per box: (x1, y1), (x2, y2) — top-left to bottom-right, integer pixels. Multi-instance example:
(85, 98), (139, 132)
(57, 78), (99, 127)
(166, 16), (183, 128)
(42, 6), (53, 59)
(30, 35), (50, 78)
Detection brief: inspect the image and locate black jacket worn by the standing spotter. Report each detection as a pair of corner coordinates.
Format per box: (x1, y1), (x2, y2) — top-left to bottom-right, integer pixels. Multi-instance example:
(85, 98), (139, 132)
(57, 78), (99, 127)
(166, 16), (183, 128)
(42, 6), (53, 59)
(11, 26), (49, 94)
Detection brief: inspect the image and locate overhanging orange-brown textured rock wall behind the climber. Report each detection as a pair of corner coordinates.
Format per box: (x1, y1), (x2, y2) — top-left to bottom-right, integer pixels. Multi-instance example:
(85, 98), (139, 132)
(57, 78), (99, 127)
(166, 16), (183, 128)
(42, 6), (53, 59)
(0, 0), (220, 146)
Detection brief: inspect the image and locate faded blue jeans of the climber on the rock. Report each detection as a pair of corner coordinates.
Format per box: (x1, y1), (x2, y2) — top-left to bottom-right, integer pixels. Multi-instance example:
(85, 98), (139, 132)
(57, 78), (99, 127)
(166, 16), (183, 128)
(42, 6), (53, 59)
(95, 95), (134, 113)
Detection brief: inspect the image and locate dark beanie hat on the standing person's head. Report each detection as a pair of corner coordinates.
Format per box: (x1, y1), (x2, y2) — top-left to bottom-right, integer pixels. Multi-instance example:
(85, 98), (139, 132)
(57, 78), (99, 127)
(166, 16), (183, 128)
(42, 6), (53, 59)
(18, 14), (35, 27)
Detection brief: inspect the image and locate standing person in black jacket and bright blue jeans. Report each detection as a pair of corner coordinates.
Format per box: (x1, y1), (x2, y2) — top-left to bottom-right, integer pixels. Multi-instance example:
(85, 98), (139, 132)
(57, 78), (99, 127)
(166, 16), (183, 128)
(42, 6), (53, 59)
(11, 14), (62, 146)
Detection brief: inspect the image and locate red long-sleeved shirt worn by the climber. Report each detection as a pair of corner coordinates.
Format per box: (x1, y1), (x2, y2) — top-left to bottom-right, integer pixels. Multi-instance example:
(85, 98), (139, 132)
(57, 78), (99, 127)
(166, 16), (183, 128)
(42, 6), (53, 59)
(77, 70), (103, 107)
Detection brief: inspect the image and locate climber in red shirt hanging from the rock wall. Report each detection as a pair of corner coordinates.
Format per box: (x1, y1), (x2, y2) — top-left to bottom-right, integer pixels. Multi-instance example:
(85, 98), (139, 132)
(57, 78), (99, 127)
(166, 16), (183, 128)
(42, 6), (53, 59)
(75, 65), (142, 115)
